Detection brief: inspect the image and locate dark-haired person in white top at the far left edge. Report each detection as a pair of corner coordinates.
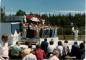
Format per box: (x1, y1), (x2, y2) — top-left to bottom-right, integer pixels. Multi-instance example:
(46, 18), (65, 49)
(0, 35), (9, 60)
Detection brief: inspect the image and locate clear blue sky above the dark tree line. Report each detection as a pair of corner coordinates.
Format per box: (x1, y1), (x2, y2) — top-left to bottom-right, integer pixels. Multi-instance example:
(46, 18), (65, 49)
(1, 0), (85, 14)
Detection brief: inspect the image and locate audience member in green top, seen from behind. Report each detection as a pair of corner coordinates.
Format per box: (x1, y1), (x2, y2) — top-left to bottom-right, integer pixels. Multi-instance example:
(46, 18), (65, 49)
(9, 42), (22, 59)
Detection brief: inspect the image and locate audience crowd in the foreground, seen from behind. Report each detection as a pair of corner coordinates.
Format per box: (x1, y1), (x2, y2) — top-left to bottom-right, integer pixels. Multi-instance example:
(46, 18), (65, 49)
(0, 35), (85, 60)
